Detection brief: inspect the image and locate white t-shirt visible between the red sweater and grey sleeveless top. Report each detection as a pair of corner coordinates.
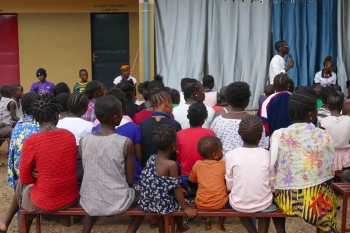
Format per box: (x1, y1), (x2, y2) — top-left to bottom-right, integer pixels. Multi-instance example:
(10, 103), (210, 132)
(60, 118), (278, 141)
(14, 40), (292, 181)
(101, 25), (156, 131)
(57, 117), (94, 146)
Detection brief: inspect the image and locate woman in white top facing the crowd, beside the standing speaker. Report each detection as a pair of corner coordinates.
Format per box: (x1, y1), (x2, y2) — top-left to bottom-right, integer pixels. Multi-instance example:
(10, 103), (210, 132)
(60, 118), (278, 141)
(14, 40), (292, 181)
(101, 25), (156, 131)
(315, 56), (337, 87)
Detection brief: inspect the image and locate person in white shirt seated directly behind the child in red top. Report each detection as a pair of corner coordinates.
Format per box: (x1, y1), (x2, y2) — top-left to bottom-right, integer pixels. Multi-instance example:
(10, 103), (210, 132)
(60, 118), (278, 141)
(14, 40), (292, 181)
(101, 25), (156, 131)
(173, 78), (215, 129)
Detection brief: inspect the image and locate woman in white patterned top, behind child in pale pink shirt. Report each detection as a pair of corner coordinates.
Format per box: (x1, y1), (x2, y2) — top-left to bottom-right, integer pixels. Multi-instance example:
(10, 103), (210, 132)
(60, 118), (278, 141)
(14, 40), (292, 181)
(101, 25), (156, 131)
(210, 82), (268, 158)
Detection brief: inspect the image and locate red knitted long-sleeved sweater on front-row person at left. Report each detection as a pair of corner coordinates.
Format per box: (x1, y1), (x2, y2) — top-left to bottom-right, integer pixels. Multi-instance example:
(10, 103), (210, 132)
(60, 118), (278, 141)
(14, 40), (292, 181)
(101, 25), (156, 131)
(19, 129), (79, 210)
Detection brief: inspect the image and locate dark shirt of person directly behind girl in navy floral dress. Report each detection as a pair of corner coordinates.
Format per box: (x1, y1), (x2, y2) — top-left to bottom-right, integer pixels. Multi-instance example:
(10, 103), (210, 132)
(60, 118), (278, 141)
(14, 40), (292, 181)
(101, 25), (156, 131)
(140, 117), (181, 168)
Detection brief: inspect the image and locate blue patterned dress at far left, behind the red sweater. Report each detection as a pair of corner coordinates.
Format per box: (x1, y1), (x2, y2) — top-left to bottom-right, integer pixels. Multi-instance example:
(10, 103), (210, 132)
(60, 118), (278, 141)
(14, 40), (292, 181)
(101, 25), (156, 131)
(7, 115), (40, 191)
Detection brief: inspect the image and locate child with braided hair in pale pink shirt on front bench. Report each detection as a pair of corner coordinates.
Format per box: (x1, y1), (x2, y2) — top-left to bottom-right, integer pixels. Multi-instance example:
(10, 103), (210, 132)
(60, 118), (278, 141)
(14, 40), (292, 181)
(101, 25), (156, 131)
(225, 115), (277, 232)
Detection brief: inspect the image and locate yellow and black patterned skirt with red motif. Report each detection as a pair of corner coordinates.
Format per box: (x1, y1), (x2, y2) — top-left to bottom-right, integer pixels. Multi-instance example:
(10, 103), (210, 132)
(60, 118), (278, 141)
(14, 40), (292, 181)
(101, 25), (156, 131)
(273, 182), (340, 233)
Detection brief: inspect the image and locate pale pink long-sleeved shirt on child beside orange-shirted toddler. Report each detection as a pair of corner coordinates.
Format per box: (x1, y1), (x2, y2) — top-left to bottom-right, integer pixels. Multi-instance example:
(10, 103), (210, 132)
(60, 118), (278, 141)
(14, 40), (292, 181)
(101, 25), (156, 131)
(225, 147), (275, 213)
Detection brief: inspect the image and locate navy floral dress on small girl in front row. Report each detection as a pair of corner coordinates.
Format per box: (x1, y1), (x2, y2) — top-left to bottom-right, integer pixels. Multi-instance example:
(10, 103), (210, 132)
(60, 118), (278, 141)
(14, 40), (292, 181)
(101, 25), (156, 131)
(138, 155), (181, 214)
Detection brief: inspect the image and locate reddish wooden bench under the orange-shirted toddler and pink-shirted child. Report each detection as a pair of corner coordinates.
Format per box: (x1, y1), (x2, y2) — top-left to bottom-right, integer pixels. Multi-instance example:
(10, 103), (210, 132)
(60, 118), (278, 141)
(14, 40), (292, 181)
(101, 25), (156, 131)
(168, 208), (323, 233)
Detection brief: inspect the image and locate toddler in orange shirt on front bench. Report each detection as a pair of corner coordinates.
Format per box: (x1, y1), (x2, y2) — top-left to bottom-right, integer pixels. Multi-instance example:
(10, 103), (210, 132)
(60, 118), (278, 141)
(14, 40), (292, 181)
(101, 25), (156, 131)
(188, 136), (228, 231)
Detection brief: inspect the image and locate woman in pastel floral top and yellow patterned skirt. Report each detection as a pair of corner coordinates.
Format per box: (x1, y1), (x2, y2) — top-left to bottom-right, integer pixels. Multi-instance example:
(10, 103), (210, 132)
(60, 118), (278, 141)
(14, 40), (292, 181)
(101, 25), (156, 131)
(270, 91), (340, 232)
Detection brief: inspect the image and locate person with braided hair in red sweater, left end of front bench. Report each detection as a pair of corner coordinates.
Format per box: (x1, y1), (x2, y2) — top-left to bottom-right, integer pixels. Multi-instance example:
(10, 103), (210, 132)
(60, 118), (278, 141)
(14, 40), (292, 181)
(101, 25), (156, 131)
(0, 96), (79, 232)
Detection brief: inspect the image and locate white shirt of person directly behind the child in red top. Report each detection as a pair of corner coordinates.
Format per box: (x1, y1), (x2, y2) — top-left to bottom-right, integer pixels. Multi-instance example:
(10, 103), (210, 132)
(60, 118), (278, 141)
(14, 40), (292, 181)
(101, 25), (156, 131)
(173, 104), (215, 129)
